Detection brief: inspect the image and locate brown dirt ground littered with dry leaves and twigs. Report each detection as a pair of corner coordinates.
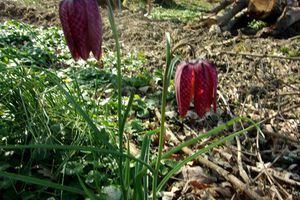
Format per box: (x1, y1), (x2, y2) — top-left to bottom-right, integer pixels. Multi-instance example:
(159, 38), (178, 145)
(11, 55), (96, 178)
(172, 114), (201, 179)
(0, 0), (300, 199)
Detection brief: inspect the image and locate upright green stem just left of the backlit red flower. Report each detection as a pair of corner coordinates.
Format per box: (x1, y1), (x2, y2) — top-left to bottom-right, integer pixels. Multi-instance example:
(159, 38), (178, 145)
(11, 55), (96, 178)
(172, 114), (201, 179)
(152, 33), (171, 200)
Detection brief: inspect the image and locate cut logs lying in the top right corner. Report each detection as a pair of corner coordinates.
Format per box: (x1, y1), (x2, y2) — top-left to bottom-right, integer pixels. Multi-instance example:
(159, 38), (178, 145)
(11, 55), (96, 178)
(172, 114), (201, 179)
(206, 0), (300, 33)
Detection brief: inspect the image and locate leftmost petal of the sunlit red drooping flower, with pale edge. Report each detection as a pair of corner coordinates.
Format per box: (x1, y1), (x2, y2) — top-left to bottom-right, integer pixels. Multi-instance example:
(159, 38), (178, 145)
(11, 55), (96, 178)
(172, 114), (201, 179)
(175, 62), (194, 117)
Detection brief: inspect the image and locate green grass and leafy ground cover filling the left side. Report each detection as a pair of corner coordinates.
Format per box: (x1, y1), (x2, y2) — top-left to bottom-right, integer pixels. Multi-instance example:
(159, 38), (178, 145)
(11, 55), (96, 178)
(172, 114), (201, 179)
(0, 21), (150, 199)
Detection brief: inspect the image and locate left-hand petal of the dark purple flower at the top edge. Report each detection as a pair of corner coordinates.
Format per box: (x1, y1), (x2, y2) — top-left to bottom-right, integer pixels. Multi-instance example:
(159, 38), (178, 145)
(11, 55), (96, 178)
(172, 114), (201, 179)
(59, 0), (80, 60)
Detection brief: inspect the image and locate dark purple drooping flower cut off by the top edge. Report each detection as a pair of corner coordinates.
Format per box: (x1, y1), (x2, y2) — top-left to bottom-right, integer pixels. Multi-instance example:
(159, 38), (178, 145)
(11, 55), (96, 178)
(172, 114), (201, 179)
(59, 0), (102, 60)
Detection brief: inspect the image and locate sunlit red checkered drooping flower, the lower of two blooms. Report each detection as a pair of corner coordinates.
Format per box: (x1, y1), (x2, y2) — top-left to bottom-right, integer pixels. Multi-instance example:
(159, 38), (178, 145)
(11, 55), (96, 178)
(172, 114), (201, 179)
(175, 60), (218, 117)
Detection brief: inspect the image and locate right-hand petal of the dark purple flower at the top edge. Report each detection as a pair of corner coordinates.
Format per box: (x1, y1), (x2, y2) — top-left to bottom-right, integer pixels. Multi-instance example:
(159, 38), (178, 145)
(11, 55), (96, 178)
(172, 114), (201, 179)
(85, 0), (102, 60)
